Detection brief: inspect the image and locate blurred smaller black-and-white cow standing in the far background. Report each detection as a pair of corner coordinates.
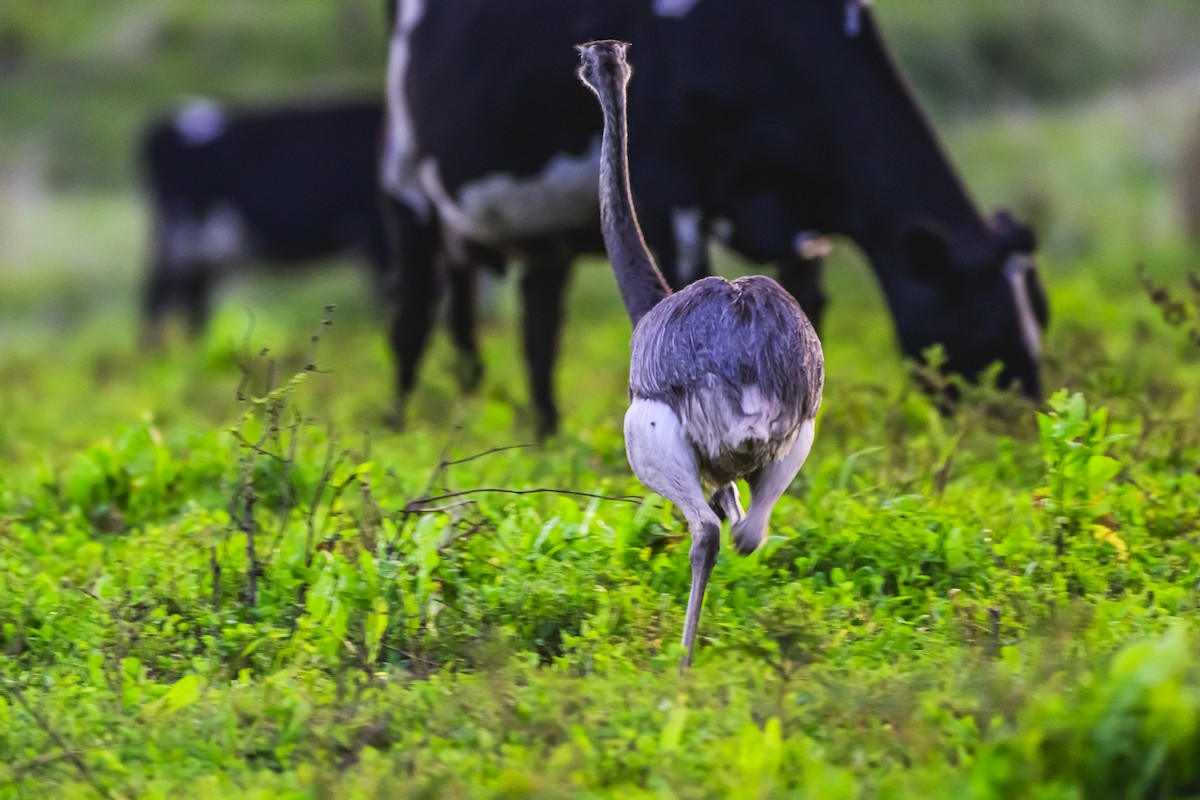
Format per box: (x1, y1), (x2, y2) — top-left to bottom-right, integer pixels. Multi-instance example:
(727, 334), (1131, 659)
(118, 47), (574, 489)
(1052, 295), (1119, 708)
(142, 101), (391, 342)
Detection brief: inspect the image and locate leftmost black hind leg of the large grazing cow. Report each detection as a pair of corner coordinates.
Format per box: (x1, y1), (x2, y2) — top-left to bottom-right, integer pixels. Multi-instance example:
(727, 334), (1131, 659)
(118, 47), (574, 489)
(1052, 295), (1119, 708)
(384, 198), (438, 426)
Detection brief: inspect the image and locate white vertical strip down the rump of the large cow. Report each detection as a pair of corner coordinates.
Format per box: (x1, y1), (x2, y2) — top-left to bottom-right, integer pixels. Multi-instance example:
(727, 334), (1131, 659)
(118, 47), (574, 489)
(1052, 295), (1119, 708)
(379, 0), (430, 221)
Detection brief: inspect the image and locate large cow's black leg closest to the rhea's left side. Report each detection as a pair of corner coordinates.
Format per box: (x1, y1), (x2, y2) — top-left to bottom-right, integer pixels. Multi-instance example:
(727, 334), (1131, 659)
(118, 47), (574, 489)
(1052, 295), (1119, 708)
(521, 257), (571, 439)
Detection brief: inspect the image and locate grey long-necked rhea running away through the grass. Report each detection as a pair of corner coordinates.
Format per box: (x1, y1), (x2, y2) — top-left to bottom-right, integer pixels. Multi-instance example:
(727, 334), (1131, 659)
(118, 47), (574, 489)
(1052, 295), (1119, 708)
(578, 41), (824, 666)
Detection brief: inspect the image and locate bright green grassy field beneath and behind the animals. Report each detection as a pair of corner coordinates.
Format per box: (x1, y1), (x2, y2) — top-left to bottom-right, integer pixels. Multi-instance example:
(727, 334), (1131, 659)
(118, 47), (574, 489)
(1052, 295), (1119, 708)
(0, 0), (1200, 800)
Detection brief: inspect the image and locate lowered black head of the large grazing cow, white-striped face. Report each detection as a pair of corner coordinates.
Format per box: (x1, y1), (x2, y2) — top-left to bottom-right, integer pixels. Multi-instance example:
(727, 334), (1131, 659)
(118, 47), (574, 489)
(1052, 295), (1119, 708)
(889, 211), (1049, 399)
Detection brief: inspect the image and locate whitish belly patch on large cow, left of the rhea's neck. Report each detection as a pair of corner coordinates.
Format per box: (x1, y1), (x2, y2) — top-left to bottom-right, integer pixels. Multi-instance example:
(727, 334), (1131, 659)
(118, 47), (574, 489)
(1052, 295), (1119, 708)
(418, 137), (600, 245)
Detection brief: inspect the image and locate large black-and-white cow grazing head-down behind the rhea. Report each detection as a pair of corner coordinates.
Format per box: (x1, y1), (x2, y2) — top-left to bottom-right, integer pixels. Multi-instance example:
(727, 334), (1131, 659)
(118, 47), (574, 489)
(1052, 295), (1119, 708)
(382, 0), (1046, 433)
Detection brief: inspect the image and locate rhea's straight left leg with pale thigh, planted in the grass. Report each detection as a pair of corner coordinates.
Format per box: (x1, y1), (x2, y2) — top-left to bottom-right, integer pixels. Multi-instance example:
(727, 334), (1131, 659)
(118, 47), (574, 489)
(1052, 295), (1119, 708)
(625, 399), (721, 667)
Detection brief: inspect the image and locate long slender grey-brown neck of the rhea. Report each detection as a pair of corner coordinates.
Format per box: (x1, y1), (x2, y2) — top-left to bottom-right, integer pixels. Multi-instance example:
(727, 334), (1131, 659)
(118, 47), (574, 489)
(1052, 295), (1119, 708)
(593, 62), (671, 327)
